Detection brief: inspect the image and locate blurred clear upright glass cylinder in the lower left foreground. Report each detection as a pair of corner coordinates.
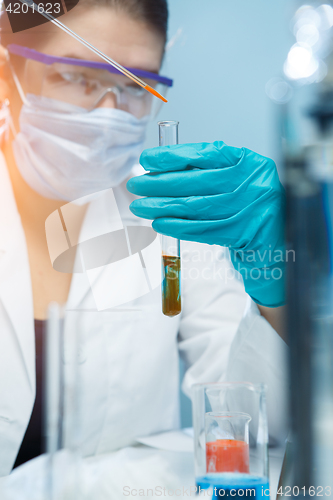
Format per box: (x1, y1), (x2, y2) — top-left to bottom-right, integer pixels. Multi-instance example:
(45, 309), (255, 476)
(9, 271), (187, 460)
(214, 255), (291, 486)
(43, 303), (82, 500)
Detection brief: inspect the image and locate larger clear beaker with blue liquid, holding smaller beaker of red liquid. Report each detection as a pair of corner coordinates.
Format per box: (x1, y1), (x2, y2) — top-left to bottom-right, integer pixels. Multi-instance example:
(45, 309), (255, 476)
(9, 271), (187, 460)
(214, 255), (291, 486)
(192, 382), (269, 498)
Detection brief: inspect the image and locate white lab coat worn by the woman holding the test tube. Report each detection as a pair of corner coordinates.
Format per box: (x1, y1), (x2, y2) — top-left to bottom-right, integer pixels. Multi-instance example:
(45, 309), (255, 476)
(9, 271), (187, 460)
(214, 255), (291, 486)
(0, 150), (285, 476)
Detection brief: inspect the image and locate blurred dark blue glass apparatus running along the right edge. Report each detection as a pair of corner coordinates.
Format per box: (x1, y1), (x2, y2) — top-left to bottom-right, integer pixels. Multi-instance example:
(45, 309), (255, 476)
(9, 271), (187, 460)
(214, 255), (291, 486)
(272, 0), (333, 497)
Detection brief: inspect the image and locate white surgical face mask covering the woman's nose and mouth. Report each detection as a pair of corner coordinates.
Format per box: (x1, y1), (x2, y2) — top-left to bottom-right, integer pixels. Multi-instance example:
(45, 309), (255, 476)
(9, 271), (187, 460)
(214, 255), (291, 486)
(13, 95), (148, 201)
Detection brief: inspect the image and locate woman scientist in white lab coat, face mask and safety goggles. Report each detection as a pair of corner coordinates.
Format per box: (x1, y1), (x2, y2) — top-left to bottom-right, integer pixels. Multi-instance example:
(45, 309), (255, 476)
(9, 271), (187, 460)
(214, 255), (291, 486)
(0, 0), (285, 484)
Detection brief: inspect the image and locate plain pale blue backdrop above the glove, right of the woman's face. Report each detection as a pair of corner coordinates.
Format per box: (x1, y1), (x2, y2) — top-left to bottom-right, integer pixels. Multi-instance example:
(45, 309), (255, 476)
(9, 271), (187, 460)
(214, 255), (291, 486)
(146, 0), (297, 168)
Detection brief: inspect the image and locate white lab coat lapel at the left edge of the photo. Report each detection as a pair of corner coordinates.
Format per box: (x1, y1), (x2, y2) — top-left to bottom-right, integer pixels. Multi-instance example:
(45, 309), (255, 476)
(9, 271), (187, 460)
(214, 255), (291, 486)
(0, 153), (35, 390)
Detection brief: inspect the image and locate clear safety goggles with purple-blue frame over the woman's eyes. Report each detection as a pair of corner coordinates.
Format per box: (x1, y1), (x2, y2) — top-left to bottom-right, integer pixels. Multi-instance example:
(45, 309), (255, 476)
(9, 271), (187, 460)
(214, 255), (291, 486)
(7, 44), (173, 118)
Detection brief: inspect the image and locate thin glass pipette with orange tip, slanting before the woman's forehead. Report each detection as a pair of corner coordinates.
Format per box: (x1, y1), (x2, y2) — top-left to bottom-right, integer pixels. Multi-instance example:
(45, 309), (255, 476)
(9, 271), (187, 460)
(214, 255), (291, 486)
(20, 0), (168, 102)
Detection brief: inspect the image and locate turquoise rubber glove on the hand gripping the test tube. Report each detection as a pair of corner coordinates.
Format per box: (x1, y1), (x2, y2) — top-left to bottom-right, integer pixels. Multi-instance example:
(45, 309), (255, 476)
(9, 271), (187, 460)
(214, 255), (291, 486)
(127, 141), (285, 307)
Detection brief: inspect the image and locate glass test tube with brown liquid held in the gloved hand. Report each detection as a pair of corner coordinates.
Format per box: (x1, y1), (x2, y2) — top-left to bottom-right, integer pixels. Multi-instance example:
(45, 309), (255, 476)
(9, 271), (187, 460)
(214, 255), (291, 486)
(158, 121), (182, 317)
